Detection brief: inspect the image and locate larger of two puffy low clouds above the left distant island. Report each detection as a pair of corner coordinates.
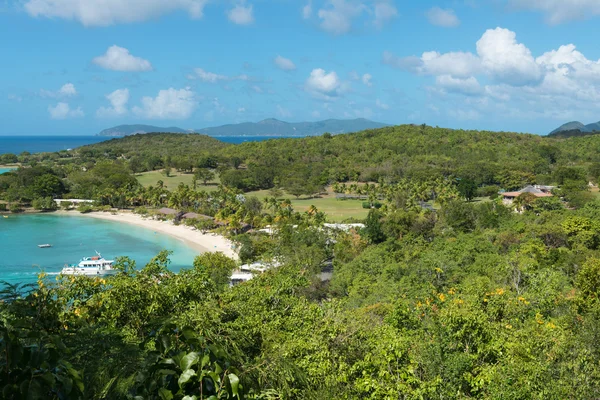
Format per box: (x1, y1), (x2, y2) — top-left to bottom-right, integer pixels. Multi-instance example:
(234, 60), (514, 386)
(133, 88), (197, 119)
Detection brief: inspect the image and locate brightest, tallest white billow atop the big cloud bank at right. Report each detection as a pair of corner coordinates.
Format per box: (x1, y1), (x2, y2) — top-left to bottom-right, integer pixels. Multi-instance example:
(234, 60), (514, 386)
(477, 28), (542, 86)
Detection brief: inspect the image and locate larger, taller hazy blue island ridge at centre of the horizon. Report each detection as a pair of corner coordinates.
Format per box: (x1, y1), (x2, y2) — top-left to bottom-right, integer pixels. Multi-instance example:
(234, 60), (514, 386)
(196, 118), (387, 136)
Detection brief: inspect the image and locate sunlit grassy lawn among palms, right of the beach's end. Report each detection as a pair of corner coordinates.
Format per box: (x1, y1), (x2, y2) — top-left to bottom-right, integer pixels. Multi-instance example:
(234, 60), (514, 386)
(246, 190), (369, 222)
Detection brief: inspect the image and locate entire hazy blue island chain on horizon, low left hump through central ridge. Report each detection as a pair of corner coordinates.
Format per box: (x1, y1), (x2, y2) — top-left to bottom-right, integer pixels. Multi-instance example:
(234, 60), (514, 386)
(98, 118), (388, 137)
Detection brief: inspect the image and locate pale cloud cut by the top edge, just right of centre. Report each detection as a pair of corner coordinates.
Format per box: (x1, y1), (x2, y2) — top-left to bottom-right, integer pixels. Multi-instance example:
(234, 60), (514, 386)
(316, 0), (398, 35)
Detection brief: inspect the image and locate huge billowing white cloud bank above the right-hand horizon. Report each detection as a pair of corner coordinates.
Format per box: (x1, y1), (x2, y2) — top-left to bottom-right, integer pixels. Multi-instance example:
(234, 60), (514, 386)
(383, 28), (600, 125)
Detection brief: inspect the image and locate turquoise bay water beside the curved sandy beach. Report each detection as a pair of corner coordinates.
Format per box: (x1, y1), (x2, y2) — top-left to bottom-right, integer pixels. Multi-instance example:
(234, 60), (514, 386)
(0, 214), (199, 283)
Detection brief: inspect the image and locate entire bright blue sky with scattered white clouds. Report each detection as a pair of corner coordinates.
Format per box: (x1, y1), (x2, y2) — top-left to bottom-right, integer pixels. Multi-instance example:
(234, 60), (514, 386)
(0, 0), (600, 135)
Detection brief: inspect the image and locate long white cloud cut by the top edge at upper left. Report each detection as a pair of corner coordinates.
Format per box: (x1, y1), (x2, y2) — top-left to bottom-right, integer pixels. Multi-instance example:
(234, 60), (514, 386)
(25, 0), (208, 26)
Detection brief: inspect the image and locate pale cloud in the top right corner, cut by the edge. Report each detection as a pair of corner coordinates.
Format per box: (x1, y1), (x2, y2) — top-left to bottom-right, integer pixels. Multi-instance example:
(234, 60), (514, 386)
(509, 0), (600, 25)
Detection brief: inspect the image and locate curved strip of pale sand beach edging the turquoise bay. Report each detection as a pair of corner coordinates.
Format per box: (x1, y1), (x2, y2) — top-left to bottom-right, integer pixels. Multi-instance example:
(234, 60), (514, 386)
(53, 211), (238, 260)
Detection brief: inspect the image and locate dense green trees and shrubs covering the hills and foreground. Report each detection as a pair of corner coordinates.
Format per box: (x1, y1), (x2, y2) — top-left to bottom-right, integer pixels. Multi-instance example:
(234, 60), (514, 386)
(0, 126), (600, 399)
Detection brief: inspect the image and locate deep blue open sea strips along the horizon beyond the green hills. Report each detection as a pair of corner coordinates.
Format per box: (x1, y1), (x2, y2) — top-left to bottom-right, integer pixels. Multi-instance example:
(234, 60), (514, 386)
(0, 136), (292, 154)
